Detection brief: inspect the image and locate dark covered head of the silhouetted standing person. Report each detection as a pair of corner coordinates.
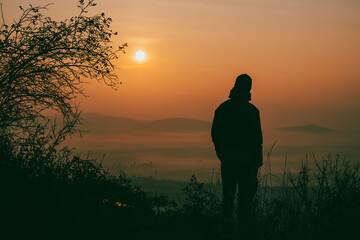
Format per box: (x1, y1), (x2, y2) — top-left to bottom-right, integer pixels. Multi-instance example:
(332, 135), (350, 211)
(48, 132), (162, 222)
(229, 74), (252, 101)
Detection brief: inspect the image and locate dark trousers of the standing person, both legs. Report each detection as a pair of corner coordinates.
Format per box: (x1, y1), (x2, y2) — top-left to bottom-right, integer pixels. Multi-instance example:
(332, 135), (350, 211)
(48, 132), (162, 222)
(221, 164), (258, 223)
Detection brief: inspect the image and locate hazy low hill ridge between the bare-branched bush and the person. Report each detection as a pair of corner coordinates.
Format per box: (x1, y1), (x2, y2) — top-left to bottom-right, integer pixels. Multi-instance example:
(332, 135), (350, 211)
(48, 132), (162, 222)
(76, 113), (211, 135)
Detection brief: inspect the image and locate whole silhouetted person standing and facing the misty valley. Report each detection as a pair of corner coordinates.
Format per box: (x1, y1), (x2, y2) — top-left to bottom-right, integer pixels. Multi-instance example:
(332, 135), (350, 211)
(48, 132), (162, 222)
(211, 74), (263, 231)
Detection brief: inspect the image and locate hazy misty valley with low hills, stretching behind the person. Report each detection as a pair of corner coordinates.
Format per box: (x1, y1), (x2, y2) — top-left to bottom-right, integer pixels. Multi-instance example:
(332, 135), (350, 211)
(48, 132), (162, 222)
(59, 113), (360, 181)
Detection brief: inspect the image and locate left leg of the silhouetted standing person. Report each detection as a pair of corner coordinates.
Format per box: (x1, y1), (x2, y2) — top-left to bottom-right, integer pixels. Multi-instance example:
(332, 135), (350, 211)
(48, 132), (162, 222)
(221, 163), (236, 220)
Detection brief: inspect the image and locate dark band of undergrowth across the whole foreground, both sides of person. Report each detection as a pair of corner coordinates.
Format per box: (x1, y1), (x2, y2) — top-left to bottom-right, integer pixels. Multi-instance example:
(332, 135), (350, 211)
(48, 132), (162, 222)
(0, 138), (360, 239)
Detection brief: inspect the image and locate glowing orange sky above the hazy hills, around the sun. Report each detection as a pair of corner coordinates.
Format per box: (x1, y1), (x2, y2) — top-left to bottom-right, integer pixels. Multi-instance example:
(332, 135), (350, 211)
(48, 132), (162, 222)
(2, 0), (360, 131)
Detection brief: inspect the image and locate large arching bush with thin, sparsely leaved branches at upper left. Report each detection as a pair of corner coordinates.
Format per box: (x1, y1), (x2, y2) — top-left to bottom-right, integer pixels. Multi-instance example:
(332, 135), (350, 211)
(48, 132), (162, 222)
(0, 0), (127, 159)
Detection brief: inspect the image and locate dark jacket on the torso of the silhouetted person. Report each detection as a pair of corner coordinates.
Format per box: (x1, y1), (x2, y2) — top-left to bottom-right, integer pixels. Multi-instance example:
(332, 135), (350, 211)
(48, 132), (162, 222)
(211, 99), (263, 167)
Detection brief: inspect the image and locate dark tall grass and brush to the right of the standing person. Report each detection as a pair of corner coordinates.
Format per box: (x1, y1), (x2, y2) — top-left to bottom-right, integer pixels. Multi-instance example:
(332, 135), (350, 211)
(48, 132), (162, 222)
(256, 154), (360, 239)
